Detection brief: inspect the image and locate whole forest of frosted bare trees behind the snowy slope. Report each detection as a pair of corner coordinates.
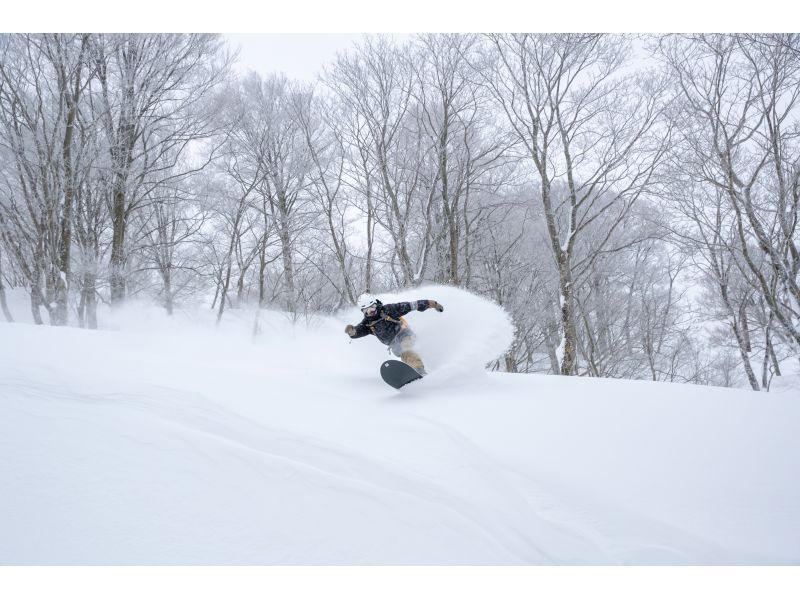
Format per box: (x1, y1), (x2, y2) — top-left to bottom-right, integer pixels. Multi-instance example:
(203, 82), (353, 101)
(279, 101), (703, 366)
(0, 34), (800, 390)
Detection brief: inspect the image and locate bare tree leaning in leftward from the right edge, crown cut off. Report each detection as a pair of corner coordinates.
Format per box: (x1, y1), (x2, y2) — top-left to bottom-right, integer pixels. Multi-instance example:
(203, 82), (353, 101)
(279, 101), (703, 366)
(658, 34), (800, 360)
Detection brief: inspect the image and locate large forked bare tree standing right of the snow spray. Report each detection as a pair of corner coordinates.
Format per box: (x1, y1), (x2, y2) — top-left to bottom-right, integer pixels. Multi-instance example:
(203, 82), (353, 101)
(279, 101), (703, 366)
(482, 34), (667, 374)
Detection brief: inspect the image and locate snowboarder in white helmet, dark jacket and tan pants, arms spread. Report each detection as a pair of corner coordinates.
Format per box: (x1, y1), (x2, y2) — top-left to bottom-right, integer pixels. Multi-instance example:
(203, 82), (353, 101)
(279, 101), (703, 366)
(344, 295), (444, 376)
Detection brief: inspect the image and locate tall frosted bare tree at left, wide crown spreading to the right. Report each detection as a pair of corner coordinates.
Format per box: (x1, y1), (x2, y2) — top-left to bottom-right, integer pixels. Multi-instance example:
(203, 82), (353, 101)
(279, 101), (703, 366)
(92, 34), (230, 304)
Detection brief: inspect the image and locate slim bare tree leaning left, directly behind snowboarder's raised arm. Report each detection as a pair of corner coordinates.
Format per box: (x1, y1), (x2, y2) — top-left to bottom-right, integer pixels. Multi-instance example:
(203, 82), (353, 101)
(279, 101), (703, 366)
(326, 37), (437, 286)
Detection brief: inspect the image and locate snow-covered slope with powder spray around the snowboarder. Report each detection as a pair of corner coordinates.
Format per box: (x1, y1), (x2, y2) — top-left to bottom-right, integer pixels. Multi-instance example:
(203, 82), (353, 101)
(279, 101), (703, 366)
(0, 287), (800, 564)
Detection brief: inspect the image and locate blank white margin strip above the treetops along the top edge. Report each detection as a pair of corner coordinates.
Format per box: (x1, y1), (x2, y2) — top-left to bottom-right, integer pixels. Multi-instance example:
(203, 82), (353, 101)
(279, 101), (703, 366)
(7, 0), (800, 36)
